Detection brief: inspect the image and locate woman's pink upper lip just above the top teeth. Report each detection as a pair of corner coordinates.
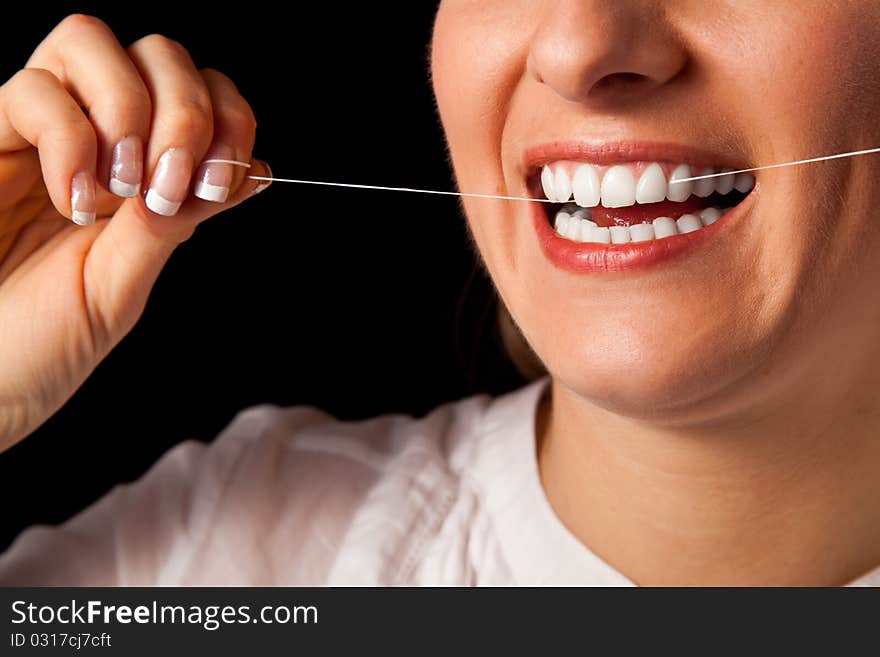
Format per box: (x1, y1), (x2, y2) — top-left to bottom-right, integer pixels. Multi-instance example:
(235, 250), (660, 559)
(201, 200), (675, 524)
(522, 141), (749, 177)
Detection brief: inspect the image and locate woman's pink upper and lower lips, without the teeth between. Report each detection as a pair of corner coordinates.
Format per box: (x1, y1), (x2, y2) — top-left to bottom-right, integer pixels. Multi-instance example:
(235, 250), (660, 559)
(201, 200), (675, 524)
(524, 142), (759, 274)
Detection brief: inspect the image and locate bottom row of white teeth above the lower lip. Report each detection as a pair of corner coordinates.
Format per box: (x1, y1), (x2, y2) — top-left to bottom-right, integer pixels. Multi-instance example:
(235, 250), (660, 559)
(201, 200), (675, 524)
(554, 206), (731, 244)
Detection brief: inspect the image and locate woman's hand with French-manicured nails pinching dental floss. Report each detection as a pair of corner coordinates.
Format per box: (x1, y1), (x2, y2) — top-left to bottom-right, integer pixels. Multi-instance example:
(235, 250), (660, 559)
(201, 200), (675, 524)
(0, 16), (269, 450)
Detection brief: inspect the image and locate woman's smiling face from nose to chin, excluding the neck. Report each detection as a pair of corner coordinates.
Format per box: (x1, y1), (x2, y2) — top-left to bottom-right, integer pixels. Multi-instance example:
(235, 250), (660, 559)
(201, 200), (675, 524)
(433, 0), (880, 418)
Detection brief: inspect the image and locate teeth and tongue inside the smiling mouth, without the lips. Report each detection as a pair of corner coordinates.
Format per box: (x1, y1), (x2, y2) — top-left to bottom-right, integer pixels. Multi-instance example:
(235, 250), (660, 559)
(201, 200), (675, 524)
(532, 160), (755, 246)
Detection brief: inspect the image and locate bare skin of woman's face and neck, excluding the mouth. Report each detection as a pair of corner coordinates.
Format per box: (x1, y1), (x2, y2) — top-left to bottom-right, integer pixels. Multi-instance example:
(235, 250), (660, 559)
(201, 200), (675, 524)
(432, 0), (880, 585)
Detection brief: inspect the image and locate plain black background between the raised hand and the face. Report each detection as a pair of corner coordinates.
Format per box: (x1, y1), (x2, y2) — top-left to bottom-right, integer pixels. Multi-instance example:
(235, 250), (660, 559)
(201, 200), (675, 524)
(0, 0), (521, 548)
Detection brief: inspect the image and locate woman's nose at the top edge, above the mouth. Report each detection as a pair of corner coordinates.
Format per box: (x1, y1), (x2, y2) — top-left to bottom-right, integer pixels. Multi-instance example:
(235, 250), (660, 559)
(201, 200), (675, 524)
(528, 0), (688, 103)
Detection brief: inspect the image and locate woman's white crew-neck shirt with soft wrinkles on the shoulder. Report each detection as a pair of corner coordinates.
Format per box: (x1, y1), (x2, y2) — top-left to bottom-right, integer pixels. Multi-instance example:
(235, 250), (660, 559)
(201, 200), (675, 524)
(0, 379), (880, 586)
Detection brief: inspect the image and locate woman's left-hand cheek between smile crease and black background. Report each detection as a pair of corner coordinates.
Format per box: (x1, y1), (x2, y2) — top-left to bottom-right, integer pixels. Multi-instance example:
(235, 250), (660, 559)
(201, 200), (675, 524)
(431, 0), (538, 280)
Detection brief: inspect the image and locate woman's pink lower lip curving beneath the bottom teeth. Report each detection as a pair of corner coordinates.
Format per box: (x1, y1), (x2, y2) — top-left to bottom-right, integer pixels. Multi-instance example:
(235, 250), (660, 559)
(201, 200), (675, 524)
(531, 191), (755, 274)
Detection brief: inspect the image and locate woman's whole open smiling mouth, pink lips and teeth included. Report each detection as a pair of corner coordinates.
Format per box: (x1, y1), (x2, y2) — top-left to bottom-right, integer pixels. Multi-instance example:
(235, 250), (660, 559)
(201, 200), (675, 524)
(527, 147), (756, 272)
